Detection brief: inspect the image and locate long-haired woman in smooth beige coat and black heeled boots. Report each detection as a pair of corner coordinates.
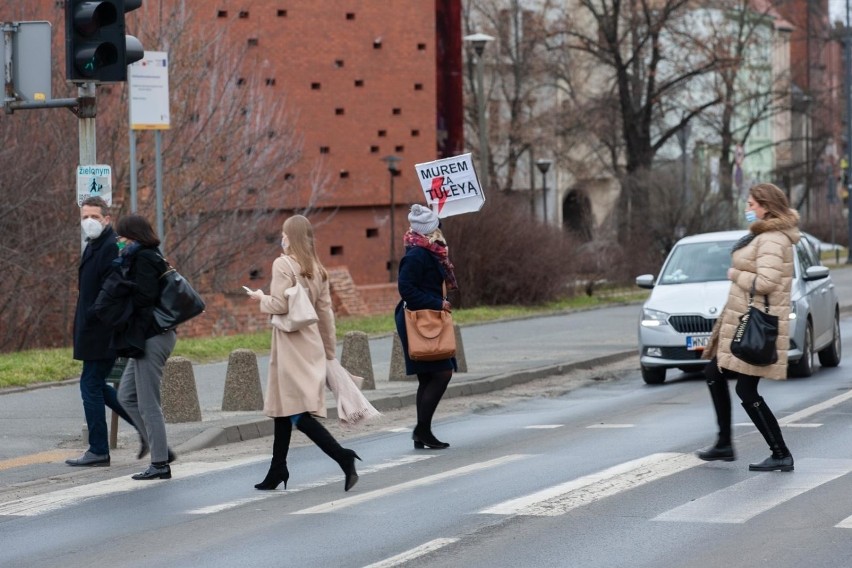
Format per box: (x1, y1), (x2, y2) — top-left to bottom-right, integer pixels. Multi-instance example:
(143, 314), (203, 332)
(249, 215), (361, 491)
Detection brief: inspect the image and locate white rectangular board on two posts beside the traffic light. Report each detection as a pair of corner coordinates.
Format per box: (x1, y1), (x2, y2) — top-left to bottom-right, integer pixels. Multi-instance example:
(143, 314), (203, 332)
(127, 51), (170, 130)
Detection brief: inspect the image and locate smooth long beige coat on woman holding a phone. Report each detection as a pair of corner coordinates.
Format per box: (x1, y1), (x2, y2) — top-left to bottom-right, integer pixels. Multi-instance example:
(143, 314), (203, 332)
(260, 254), (336, 418)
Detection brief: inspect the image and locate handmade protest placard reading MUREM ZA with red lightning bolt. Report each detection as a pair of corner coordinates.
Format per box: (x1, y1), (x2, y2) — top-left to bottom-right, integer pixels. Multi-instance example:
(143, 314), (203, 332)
(414, 153), (485, 218)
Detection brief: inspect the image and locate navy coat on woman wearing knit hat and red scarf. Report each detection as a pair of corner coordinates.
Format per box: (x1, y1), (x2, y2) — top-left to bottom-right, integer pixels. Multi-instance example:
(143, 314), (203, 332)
(394, 247), (457, 375)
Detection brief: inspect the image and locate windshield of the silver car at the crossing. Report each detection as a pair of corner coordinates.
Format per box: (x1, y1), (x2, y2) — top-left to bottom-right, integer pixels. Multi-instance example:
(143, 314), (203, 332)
(657, 241), (735, 284)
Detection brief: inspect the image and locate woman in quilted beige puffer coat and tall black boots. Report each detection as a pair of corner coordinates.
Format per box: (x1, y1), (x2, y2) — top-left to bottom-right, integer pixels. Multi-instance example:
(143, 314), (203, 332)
(697, 183), (799, 471)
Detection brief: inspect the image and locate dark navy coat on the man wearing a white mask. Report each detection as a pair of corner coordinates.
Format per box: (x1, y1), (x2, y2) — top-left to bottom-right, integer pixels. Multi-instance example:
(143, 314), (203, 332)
(74, 225), (118, 361)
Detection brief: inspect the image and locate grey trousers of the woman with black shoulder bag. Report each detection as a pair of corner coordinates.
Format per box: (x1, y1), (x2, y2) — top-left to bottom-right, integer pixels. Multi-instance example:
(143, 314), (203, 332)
(118, 331), (177, 463)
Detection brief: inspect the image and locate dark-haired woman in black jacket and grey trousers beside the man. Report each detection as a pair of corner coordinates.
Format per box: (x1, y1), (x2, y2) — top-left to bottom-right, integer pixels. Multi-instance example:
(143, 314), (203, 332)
(113, 215), (177, 479)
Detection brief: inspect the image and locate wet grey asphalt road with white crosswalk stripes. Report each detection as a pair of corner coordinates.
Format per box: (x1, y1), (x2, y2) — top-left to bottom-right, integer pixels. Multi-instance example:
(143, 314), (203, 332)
(5, 318), (852, 568)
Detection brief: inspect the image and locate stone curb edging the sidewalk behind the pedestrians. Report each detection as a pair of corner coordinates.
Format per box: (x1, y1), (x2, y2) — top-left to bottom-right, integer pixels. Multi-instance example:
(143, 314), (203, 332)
(175, 349), (636, 454)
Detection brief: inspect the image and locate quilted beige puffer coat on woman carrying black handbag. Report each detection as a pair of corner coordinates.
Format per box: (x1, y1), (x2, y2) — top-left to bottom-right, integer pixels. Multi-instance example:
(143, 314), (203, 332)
(703, 210), (799, 379)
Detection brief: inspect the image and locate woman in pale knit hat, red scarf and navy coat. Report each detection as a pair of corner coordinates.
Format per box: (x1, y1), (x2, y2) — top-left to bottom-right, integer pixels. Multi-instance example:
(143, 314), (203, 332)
(395, 204), (458, 450)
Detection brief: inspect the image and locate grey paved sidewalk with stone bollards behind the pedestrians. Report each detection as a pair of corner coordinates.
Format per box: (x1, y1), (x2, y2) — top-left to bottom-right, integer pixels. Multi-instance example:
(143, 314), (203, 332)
(5, 269), (852, 470)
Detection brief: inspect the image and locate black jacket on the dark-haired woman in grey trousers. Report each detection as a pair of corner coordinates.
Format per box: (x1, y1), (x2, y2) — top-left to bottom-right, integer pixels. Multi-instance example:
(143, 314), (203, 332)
(112, 247), (168, 359)
